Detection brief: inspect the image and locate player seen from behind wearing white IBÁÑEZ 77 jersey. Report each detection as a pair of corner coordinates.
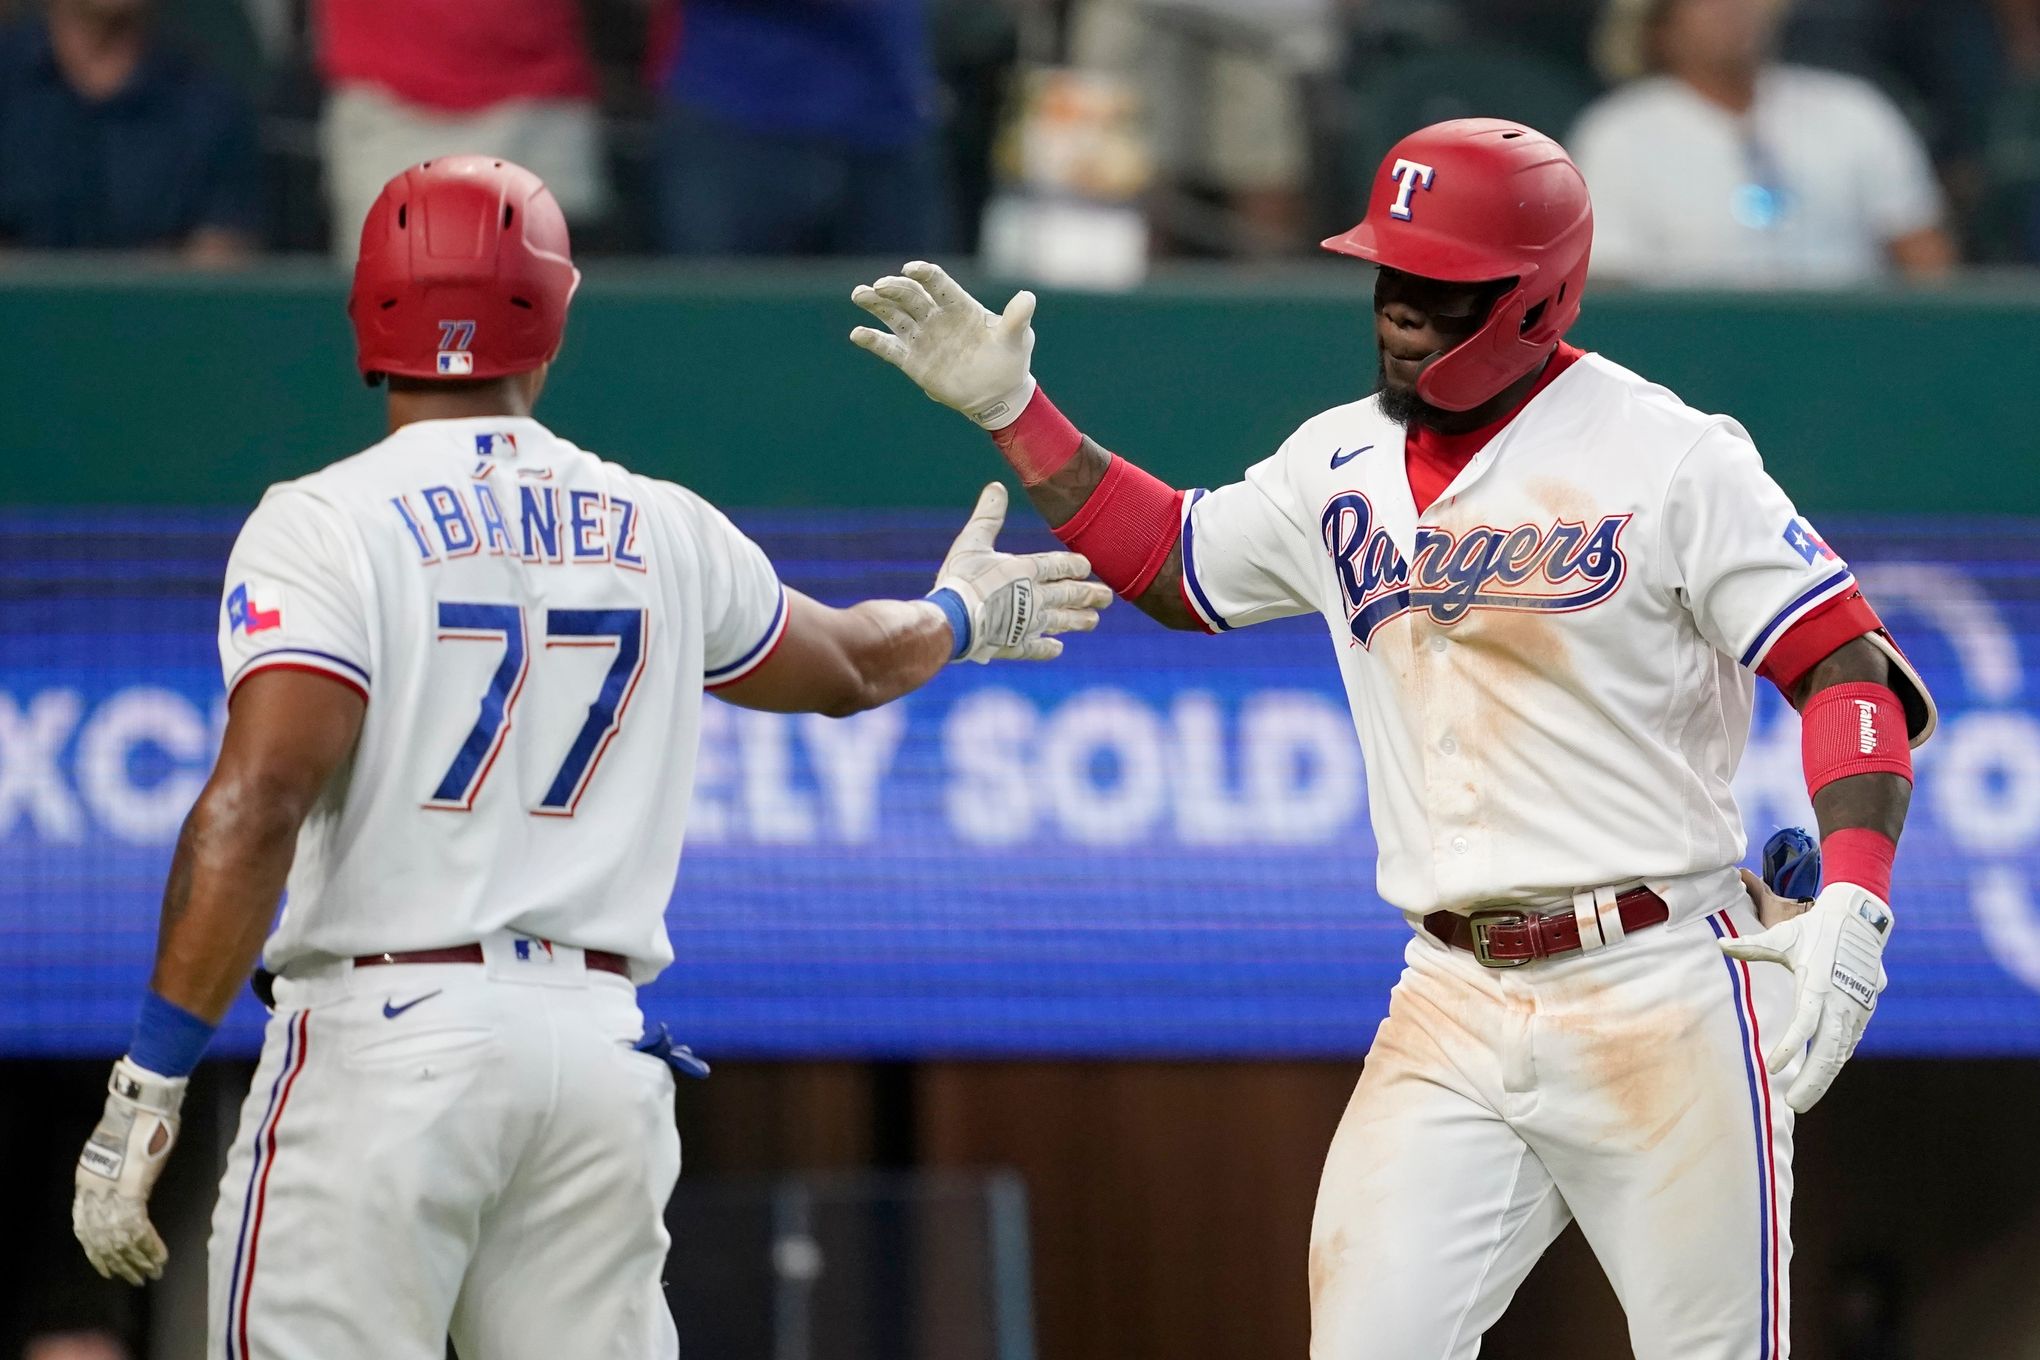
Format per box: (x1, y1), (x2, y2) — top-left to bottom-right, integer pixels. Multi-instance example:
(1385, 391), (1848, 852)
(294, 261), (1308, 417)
(73, 157), (1110, 1360)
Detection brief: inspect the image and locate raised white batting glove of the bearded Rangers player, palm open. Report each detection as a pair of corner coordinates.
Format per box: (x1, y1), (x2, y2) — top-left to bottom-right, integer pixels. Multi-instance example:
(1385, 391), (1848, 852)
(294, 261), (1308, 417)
(851, 259), (1034, 430)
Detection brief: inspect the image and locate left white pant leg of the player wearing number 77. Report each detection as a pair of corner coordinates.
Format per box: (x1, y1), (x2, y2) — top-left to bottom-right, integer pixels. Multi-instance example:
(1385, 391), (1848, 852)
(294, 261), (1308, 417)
(206, 966), (526, 1360)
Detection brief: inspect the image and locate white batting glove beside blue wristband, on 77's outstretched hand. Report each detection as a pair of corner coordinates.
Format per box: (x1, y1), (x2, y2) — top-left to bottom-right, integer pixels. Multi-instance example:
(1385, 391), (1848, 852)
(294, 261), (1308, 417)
(934, 481), (1112, 663)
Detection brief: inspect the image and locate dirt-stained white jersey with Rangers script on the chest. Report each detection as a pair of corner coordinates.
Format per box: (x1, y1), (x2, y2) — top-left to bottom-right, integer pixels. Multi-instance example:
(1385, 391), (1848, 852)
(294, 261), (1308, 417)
(1181, 355), (1854, 911)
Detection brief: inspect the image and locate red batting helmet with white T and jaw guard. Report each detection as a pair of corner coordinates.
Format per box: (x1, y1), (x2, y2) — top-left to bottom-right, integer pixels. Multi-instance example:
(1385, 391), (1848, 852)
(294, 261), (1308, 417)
(1324, 118), (1593, 410)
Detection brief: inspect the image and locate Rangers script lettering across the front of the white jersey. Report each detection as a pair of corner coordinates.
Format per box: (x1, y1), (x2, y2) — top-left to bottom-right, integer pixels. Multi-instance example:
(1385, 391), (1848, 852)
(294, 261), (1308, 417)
(1318, 491), (1630, 646)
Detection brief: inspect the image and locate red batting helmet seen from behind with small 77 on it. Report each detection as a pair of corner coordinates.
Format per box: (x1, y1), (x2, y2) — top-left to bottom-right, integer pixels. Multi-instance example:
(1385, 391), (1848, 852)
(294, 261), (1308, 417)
(347, 155), (581, 383)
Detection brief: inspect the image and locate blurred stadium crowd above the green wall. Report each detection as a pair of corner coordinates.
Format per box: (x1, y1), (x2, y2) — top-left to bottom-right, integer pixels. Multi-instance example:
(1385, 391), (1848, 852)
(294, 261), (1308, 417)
(0, 0), (2040, 285)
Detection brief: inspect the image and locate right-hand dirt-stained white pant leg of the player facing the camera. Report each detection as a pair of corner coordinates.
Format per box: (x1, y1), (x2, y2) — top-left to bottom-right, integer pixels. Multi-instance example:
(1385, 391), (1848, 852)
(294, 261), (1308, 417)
(1524, 895), (1797, 1360)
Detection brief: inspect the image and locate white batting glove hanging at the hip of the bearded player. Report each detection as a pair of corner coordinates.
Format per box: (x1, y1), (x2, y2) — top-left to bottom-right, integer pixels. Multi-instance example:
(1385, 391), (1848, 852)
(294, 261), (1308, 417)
(1722, 883), (1891, 1113)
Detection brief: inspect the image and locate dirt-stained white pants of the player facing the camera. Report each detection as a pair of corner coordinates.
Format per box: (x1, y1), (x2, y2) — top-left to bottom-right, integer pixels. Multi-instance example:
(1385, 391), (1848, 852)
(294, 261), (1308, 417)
(1310, 891), (1799, 1360)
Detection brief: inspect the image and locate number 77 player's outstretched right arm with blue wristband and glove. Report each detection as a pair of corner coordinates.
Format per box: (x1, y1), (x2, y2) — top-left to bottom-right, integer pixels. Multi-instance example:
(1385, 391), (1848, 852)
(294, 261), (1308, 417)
(716, 483), (1112, 718)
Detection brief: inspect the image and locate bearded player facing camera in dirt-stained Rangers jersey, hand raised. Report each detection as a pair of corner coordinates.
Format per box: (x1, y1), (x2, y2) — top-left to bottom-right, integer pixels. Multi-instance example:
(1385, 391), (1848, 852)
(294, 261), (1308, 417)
(851, 118), (1934, 1360)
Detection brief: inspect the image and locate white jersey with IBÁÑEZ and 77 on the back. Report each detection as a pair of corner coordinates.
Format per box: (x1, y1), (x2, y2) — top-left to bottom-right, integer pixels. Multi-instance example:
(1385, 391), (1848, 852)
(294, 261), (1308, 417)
(220, 418), (785, 981)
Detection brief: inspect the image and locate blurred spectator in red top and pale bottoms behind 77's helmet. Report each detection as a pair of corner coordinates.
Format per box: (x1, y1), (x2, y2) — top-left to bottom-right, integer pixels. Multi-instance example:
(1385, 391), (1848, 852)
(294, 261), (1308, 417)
(316, 0), (610, 267)
